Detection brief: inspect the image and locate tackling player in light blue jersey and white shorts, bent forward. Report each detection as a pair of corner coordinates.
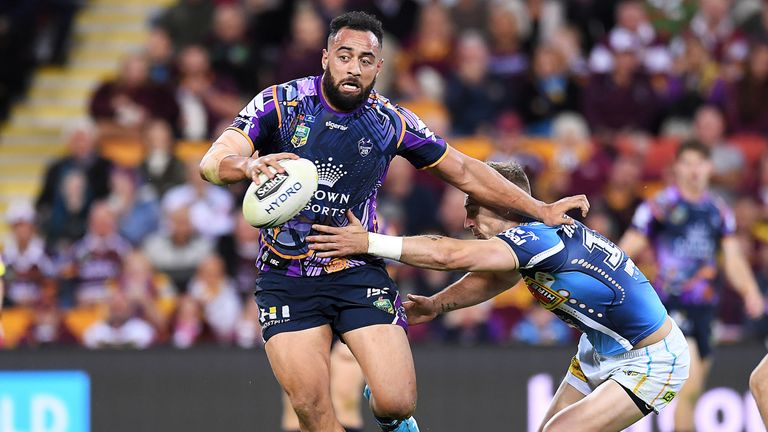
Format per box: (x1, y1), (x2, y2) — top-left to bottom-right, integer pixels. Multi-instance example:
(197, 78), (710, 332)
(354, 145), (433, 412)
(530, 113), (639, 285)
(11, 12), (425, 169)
(308, 163), (689, 432)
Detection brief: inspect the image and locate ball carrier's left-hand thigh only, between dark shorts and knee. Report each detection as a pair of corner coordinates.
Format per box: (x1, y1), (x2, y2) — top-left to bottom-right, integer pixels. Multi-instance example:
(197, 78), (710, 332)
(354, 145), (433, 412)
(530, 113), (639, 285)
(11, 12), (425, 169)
(264, 325), (332, 408)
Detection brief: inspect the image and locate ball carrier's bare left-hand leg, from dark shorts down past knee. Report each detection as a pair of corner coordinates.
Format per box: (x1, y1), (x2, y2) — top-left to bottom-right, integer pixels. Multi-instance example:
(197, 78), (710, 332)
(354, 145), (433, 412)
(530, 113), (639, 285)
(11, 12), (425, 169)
(265, 325), (344, 432)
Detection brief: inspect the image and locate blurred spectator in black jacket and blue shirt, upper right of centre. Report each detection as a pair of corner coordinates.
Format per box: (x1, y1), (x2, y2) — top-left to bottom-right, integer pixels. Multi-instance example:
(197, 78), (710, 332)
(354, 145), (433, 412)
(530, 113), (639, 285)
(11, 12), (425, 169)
(520, 45), (581, 135)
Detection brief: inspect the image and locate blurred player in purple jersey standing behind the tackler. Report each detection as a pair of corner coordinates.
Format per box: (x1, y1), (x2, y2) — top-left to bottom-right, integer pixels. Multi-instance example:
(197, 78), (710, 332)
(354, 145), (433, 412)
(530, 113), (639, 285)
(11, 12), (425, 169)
(619, 141), (764, 432)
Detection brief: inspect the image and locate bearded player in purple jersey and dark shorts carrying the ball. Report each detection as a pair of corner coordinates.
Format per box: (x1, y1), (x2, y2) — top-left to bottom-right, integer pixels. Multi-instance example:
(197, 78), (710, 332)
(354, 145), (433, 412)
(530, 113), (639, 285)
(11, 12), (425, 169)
(200, 12), (589, 432)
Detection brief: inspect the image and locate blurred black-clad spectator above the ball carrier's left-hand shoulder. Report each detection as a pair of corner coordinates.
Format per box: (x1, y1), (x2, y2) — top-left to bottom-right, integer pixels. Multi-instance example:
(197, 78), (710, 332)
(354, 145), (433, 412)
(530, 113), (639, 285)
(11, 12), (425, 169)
(206, 4), (260, 94)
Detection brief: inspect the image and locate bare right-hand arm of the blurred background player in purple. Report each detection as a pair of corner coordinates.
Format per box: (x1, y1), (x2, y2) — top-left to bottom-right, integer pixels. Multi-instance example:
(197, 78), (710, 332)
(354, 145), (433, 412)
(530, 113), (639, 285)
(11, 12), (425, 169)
(722, 235), (765, 319)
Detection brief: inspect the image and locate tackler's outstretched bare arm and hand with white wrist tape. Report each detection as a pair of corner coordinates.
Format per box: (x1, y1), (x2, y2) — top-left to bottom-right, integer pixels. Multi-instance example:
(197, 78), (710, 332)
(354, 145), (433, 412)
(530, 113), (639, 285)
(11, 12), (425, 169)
(307, 210), (517, 271)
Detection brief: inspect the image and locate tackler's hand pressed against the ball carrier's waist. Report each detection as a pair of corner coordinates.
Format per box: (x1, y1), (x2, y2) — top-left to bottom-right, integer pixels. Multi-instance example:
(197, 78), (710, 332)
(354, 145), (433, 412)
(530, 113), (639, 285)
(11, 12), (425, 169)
(307, 210), (368, 258)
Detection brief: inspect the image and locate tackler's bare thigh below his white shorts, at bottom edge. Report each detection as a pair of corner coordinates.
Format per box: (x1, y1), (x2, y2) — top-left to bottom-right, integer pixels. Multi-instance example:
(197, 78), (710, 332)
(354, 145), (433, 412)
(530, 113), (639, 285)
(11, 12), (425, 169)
(543, 380), (643, 432)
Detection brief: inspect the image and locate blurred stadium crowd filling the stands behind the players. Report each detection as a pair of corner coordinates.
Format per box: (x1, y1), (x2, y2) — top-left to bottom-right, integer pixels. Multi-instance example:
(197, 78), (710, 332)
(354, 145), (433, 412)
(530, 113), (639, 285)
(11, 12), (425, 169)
(2, 0), (768, 348)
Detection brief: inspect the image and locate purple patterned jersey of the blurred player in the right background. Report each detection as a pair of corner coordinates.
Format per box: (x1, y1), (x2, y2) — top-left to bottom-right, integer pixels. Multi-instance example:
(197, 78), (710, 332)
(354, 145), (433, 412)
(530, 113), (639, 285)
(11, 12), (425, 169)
(632, 186), (736, 305)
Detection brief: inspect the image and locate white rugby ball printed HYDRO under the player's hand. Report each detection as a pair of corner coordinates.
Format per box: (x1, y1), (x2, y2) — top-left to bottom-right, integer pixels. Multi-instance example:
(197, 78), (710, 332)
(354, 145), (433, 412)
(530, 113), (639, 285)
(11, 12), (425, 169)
(243, 159), (317, 228)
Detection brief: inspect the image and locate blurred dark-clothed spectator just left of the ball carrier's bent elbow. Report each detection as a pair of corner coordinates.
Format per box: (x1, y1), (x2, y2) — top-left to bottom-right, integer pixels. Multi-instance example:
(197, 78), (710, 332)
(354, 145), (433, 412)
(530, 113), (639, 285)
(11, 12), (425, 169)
(139, 119), (187, 198)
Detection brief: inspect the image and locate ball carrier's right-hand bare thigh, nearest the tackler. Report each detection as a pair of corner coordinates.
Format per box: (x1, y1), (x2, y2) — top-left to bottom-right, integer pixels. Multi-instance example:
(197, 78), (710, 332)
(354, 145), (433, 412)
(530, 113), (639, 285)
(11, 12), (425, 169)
(343, 324), (416, 417)
